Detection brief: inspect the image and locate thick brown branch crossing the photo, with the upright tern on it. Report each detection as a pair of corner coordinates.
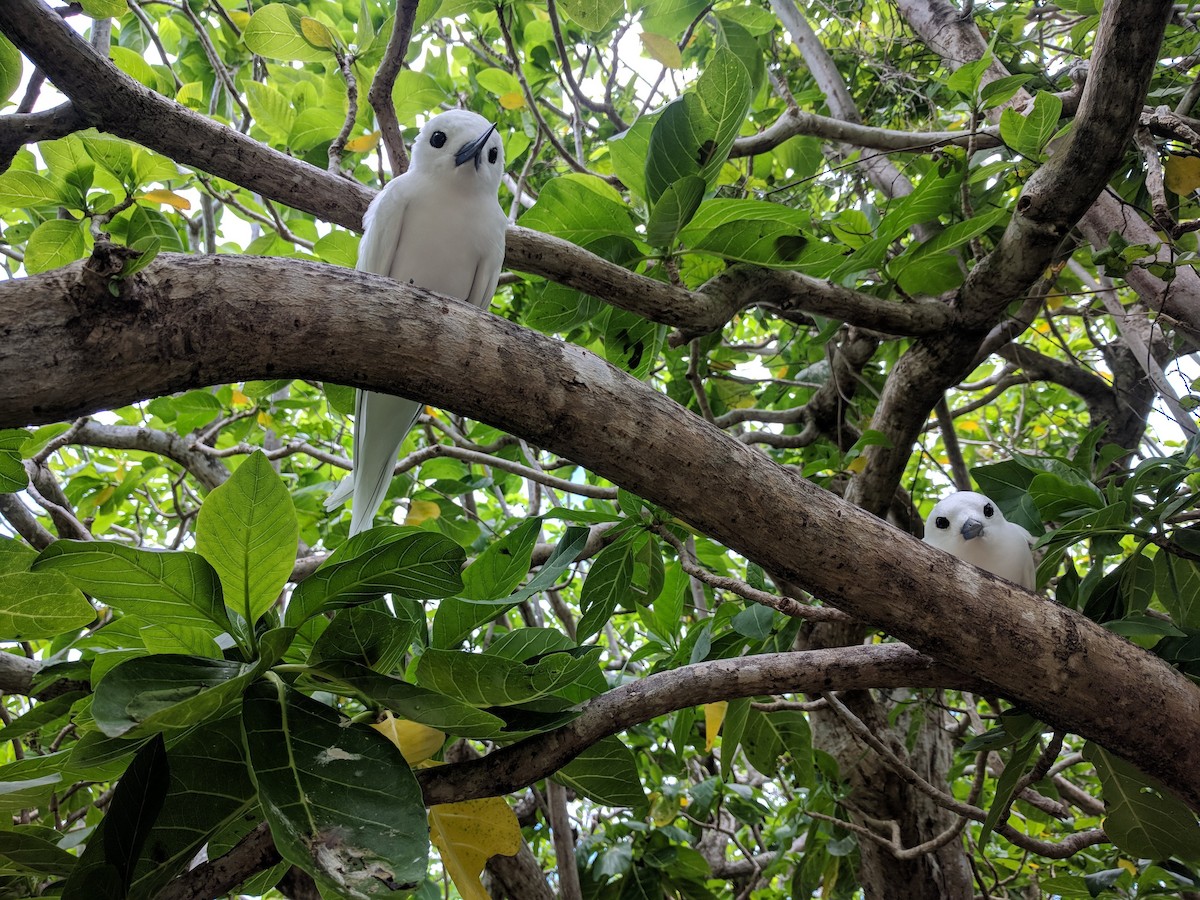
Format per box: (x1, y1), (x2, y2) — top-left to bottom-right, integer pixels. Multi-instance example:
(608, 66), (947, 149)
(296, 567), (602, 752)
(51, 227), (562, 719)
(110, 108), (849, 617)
(0, 256), (1200, 808)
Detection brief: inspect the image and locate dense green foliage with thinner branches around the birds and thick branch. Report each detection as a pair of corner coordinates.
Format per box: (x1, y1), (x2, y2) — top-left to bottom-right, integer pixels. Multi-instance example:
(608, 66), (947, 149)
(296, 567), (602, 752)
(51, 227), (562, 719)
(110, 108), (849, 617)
(0, 0), (1200, 900)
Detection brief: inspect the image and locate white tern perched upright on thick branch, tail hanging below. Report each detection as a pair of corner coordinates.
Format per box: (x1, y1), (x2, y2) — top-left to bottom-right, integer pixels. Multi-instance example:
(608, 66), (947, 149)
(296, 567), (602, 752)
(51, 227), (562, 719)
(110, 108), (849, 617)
(325, 109), (508, 534)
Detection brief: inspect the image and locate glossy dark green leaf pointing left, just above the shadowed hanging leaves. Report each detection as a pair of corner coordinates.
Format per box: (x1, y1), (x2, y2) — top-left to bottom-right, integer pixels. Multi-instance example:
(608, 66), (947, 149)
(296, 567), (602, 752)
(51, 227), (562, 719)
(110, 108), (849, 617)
(91, 654), (260, 738)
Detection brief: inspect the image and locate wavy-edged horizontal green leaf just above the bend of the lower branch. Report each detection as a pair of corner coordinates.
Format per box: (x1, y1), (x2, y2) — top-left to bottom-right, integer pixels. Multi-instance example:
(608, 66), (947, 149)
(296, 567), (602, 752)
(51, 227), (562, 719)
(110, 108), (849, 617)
(416, 647), (600, 707)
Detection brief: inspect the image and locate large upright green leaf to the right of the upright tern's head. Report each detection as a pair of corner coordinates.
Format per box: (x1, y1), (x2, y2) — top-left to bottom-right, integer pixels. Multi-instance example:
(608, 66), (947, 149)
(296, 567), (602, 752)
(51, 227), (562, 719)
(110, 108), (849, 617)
(646, 47), (750, 203)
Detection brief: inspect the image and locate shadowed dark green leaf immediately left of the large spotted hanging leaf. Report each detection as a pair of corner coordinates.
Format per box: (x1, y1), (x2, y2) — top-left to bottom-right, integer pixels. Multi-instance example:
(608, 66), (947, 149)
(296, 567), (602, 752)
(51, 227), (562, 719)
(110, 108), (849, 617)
(130, 716), (254, 900)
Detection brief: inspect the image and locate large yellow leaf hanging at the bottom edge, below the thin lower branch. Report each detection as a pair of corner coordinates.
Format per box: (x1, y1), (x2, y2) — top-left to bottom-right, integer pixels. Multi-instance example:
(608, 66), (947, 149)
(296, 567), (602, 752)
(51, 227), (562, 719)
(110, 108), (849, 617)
(430, 797), (521, 900)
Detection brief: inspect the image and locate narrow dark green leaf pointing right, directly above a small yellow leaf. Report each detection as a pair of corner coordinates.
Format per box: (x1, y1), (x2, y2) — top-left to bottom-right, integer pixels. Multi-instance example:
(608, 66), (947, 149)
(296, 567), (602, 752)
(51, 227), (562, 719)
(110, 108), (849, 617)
(304, 660), (504, 738)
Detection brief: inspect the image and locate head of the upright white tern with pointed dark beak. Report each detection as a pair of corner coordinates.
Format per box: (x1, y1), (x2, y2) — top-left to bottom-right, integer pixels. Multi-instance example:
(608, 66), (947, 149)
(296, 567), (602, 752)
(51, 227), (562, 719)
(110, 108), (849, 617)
(409, 109), (504, 192)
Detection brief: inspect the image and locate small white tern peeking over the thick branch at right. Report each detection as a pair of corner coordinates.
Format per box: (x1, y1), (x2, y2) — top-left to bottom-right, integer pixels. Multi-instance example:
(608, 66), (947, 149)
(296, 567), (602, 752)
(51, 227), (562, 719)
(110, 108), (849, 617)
(925, 491), (1037, 590)
